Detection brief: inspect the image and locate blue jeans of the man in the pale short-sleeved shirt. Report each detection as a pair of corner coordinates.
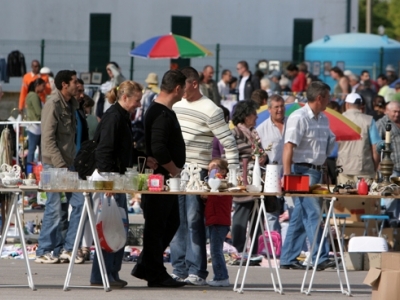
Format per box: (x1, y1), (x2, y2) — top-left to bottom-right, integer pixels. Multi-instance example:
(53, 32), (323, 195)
(281, 165), (329, 265)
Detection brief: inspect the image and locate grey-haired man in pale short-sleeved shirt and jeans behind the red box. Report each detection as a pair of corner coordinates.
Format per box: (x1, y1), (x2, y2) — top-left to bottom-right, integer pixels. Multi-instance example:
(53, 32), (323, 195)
(280, 81), (335, 270)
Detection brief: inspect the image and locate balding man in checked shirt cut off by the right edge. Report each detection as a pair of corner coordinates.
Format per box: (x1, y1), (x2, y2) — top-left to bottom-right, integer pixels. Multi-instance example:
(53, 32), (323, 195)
(376, 101), (400, 220)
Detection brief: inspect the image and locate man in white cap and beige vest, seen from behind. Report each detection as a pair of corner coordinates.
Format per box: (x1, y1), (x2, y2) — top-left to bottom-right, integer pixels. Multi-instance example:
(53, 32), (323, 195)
(336, 93), (380, 184)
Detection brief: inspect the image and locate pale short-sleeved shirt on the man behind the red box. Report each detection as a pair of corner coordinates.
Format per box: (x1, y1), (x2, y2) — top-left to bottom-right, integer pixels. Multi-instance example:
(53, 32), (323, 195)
(284, 103), (335, 166)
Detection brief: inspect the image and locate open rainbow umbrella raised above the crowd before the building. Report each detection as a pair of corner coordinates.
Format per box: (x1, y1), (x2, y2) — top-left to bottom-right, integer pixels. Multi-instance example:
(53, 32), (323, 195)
(130, 33), (212, 59)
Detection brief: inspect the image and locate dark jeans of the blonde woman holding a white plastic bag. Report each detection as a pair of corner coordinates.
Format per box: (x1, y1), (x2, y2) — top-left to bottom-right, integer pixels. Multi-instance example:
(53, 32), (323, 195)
(90, 194), (128, 283)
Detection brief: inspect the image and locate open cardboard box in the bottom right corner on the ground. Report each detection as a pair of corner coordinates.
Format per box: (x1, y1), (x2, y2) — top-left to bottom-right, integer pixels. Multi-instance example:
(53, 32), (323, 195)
(364, 252), (400, 300)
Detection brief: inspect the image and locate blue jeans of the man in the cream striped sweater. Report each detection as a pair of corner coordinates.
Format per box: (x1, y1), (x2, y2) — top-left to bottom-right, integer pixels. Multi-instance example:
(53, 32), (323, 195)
(170, 195), (208, 279)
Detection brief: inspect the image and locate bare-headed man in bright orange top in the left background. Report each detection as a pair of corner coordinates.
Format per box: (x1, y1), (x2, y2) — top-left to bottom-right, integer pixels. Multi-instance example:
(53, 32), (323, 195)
(18, 59), (51, 112)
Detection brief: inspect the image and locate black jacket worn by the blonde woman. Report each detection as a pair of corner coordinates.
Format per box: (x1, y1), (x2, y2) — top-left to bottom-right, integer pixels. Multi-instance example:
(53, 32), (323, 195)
(95, 102), (134, 174)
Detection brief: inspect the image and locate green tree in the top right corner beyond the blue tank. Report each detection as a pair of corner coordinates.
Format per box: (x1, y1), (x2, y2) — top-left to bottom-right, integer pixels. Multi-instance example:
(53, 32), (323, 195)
(358, 0), (400, 38)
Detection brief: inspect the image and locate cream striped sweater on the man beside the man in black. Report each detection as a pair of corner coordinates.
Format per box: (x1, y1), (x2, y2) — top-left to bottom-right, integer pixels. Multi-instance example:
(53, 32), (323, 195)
(173, 96), (239, 169)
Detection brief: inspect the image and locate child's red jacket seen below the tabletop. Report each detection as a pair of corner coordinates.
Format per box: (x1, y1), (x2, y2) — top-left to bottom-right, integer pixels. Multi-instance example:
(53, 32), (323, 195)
(204, 195), (232, 226)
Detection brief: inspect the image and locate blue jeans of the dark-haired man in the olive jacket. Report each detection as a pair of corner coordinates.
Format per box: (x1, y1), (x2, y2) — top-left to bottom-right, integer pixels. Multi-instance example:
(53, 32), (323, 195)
(36, 165), (84, 257)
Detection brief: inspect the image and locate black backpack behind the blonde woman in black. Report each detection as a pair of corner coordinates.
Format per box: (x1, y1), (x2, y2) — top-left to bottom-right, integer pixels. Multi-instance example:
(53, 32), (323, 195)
(74, 124), (100, 180)
